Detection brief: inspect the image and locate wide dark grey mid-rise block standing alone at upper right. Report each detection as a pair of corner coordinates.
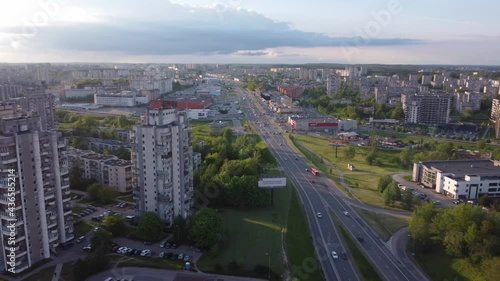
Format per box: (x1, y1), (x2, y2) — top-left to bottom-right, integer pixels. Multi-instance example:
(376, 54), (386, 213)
(401, 93), (451, 125)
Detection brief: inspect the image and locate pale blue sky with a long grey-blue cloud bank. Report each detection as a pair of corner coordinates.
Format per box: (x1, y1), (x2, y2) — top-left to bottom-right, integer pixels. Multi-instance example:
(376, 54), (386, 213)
(0, 0), (500, 65)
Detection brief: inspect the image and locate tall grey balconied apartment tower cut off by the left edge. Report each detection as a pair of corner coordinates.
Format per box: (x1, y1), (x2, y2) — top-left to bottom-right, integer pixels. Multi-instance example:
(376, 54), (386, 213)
(0, 96), (73, 273)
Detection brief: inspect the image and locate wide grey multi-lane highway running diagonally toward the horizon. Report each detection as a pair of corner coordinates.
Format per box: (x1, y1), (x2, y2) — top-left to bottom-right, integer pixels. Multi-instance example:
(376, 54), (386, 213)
(232, 87), (425, 281)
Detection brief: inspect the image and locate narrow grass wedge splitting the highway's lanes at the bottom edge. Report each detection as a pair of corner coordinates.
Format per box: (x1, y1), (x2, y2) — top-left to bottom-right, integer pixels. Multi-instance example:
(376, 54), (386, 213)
(328, 209), (383, 281)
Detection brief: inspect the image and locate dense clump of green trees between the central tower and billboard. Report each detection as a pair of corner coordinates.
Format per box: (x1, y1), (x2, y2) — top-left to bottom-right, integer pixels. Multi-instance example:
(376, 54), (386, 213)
(193, 128), (275, 208)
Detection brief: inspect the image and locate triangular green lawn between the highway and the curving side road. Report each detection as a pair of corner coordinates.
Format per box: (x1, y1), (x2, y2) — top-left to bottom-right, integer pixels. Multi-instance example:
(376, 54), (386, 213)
(353, 206), (410, 242)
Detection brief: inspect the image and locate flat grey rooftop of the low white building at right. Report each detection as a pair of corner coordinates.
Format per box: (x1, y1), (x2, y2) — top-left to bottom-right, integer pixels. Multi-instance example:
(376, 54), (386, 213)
(420, 160), (500, 178)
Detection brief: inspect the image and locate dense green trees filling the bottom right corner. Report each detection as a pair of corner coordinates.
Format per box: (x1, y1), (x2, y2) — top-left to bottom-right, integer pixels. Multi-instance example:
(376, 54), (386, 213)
(409, 203), (500, 280)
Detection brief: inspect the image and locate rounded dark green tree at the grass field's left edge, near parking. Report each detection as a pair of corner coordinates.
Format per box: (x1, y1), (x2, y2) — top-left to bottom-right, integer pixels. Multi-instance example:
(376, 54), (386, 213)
(190, 208), (225, 248)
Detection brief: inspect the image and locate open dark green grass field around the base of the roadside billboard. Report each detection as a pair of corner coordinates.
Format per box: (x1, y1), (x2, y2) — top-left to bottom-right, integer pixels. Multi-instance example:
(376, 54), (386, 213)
(197, 180), (323, 280)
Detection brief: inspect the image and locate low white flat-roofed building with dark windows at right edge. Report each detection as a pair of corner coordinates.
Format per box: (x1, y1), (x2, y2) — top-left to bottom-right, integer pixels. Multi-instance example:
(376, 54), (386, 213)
(413, 160), (500, 200)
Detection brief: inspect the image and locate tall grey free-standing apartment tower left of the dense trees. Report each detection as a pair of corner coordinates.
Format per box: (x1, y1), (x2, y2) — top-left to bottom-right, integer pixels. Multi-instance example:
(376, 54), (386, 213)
(131, 104), (194, 225)
